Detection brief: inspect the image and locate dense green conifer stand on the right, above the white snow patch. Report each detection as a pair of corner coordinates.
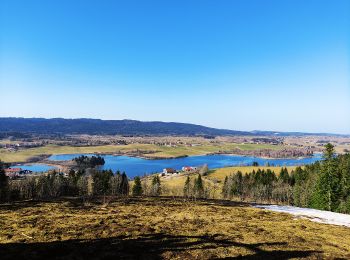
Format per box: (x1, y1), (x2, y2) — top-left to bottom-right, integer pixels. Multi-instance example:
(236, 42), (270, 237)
(222, 144), (350, 213)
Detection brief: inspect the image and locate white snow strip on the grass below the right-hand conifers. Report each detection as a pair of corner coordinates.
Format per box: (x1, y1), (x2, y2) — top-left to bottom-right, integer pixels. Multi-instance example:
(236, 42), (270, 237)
(253, 205), (350, 227)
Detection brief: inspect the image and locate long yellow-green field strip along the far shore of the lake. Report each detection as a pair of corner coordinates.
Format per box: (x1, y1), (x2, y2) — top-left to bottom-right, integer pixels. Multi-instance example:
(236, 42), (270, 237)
(0, 144), (283, 162)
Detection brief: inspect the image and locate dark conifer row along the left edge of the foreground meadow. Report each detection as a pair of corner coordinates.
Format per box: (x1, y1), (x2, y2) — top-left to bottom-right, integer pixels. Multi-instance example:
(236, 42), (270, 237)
(0, 169), (129, 202)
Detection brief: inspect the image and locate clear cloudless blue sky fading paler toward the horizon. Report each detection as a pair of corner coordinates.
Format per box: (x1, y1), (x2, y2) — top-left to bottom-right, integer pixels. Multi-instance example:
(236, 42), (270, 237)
(0, 0), (350, 134)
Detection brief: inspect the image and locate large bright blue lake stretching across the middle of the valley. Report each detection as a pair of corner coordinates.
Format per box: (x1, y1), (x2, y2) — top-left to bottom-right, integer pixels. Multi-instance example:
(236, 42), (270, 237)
(48, 154), (322, 178)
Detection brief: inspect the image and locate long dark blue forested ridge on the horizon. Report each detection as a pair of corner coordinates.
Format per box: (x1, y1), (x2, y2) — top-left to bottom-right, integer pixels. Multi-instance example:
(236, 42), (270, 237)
(0, 117), (346, 136)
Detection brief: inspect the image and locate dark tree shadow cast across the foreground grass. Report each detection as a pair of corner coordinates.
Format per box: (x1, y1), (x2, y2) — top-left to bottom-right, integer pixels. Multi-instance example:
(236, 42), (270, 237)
(0, 233), (320, 260)
